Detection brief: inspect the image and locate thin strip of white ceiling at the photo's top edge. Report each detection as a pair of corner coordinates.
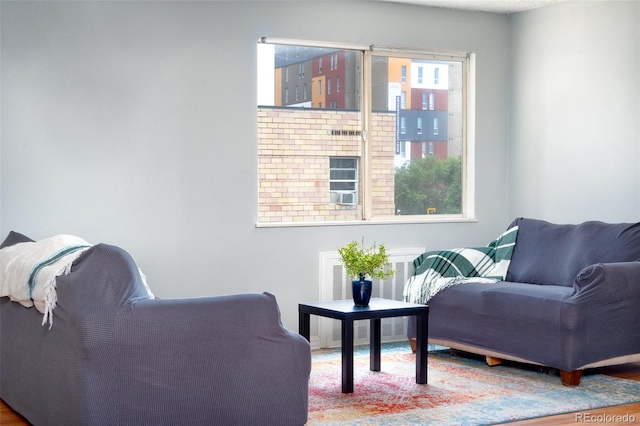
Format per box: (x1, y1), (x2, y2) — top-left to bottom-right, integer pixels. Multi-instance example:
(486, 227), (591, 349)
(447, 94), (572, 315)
(383, 0), (567, 13)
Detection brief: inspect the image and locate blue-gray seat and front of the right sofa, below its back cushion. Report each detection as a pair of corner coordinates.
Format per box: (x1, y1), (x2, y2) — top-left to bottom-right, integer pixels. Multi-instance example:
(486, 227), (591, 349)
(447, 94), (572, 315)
(429, 281), (573, 365)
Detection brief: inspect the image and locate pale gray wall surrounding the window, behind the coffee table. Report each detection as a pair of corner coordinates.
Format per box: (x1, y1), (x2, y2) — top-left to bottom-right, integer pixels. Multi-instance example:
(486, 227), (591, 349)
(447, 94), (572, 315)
(0, 1), (511, 329)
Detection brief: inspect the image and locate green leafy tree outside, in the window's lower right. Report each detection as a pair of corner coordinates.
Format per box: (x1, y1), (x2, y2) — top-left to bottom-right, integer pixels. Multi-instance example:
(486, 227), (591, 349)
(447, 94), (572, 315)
(395, 156), (462, 215)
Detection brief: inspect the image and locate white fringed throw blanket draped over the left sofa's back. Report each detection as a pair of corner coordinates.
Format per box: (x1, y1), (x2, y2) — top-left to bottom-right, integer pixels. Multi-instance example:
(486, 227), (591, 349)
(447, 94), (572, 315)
(0, 235), (91, 328)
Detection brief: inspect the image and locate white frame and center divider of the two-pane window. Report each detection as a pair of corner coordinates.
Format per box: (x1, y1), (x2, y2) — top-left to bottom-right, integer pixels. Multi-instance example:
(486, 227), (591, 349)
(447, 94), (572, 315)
(256, 37), (477, 227)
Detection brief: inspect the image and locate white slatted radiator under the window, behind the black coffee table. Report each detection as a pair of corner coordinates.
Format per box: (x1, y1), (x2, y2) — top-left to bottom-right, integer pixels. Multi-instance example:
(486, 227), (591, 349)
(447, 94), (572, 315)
(310, 247), (425, 348)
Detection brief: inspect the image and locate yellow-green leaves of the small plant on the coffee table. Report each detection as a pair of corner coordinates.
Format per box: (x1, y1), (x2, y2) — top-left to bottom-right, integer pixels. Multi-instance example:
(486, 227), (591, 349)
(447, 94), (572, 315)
(338, 238), (396, 280)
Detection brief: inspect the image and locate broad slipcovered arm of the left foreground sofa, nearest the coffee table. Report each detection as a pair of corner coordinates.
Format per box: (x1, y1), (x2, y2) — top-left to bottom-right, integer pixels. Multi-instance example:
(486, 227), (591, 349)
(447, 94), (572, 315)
(115, 293), (311, 425)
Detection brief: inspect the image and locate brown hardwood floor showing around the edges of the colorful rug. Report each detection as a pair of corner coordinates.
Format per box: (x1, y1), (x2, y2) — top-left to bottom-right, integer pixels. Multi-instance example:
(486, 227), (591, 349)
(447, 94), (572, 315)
(0, 363), (640, 426)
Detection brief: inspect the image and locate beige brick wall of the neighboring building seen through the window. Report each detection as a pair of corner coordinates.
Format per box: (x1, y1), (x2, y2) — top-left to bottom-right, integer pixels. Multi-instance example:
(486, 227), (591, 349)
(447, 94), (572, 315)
(258, 108), (395, 222)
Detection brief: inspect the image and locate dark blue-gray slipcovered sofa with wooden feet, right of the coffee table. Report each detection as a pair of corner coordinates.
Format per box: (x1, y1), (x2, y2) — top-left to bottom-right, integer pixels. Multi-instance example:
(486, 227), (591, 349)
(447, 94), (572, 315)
(409, 218), (640, 386)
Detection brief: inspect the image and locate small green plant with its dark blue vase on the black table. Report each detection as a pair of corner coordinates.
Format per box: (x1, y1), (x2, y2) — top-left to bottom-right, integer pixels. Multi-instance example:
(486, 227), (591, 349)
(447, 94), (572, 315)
(338, 238), (396, 306)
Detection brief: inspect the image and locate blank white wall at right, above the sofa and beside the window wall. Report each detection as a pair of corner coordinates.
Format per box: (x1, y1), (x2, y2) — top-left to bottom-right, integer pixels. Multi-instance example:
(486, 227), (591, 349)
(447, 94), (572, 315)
(509, 1), (640, 223)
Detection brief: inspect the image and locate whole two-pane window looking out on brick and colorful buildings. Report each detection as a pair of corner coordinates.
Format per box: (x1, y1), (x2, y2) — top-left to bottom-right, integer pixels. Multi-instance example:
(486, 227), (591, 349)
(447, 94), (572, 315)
(257, 38), (474, 226)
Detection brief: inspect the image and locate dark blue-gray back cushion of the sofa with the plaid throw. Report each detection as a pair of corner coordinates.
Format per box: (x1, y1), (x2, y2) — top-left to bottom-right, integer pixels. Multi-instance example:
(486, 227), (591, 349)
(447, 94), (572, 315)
(506, 218), (640, 287)
